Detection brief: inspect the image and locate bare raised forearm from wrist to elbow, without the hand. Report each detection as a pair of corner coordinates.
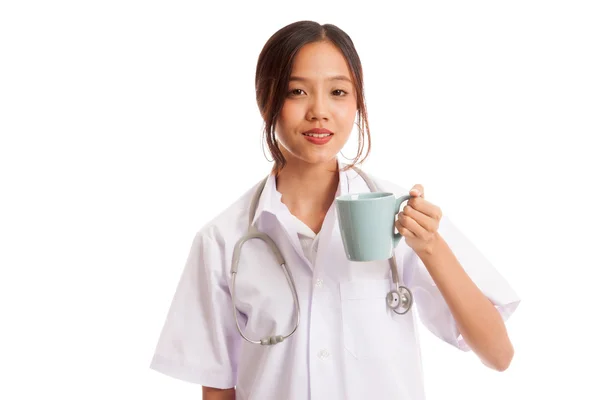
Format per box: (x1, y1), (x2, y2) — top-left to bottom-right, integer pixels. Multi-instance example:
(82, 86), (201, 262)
(417, 235), (514, 371)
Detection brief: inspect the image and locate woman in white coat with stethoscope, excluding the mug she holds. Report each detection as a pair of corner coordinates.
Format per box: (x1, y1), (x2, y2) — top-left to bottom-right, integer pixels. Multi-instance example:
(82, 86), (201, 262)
(151, 21), (519, 400)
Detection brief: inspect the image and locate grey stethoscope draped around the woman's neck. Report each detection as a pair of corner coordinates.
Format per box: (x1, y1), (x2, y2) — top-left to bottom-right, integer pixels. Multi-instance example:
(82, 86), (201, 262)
(231, 167), (413, 345)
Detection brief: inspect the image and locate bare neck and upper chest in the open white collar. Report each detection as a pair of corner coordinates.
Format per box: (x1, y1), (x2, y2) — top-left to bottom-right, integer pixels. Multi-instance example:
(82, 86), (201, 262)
(276, 159), (339, 232)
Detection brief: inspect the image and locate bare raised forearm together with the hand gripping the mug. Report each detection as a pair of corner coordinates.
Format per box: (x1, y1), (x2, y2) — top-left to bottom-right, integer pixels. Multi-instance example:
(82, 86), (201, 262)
(396, 184), (514, 371)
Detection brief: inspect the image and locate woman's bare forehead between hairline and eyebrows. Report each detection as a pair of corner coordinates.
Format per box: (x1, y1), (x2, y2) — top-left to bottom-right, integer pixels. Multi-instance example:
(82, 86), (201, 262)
(292, 42), (351, 80)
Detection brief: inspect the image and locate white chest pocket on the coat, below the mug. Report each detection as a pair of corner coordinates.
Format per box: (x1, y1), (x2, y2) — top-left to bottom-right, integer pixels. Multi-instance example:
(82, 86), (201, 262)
(340, 279), (401, 359)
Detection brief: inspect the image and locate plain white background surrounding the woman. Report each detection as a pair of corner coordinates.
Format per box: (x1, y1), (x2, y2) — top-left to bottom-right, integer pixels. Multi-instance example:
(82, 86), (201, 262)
(0, 0), (600, 400)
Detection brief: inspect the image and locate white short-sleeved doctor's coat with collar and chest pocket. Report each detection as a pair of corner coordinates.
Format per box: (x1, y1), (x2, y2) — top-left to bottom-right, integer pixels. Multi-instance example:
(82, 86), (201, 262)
(151, 164), (520, 400)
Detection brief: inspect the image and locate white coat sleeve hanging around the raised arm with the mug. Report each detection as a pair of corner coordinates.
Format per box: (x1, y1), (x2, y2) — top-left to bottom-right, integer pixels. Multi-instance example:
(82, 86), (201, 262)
(403, 216), (520, 351)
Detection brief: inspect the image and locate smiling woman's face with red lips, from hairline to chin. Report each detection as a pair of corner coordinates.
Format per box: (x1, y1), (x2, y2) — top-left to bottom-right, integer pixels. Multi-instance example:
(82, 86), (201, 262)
(275, 42), (357, 169)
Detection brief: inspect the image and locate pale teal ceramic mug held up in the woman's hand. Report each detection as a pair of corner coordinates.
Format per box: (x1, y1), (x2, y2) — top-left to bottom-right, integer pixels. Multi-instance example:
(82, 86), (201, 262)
(335, 192), (411, 261)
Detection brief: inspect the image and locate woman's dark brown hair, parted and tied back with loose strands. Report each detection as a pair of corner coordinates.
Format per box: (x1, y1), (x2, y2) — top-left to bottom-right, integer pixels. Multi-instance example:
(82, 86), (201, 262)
(255, 21), (371, 174)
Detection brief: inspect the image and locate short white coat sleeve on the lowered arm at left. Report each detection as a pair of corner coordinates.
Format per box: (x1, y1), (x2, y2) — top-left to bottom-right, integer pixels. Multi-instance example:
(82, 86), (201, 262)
(150, 232), (240, 389)
